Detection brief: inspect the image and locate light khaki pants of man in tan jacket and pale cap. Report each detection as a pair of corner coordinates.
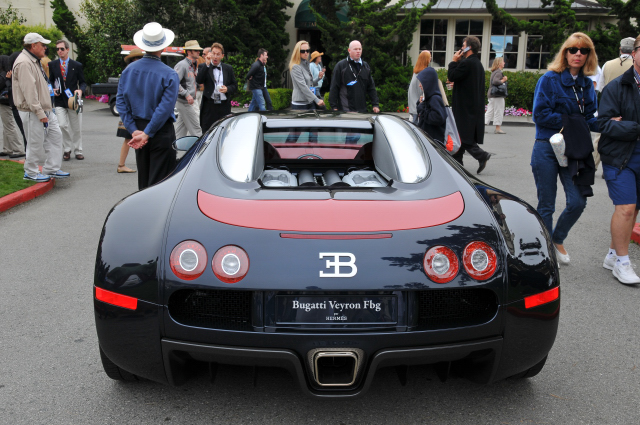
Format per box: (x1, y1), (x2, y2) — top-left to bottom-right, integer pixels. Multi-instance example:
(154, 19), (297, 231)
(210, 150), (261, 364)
(20, 111), (62, 177)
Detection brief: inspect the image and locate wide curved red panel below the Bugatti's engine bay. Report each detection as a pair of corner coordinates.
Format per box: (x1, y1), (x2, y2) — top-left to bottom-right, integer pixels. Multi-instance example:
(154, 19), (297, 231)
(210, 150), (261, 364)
(198, 190), (464, 232)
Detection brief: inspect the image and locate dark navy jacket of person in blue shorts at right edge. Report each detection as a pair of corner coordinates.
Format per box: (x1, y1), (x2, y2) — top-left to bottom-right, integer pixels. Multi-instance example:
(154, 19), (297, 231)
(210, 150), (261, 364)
(598, 66), (640, 168)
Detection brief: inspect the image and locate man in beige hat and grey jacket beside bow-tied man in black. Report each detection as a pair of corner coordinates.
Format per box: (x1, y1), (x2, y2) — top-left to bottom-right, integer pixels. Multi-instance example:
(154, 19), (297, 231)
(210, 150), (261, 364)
(173, 40), (202, 139)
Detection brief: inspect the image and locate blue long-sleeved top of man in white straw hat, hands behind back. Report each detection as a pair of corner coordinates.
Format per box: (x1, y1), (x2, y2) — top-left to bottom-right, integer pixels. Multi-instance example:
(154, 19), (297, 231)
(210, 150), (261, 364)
(116, 55), (180, 137)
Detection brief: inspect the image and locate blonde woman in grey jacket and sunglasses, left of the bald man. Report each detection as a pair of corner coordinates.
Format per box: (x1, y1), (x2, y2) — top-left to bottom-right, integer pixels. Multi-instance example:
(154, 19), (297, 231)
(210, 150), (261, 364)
(289, 40), (324, 110)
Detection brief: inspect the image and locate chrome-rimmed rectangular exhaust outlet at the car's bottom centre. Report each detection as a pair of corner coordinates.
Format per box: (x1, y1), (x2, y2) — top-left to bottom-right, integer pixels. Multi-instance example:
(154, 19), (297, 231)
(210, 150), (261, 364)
(308, 348), (364, 387)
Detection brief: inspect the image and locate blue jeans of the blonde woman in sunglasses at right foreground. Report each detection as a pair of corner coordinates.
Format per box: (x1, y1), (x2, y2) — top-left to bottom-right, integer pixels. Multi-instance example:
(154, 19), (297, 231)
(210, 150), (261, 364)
(531, 140), (587, 245)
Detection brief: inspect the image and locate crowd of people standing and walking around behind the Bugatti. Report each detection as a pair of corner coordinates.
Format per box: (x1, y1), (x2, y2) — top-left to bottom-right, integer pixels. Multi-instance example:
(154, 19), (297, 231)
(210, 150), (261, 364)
(0, 23), (640, 284)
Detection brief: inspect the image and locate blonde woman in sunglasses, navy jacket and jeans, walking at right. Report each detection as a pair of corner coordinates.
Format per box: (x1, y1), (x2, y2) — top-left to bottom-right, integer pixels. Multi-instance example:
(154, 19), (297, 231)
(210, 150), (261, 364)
(531, 32), (598, 264)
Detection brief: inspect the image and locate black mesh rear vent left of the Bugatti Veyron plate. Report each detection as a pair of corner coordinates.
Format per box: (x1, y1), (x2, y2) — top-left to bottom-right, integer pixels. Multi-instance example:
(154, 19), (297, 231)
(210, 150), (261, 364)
(169, 289), (253, 331)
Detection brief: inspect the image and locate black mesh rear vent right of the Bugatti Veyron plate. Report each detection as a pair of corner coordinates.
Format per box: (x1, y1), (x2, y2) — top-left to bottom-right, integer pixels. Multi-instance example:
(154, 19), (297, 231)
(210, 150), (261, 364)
(417, 288), (498, 329)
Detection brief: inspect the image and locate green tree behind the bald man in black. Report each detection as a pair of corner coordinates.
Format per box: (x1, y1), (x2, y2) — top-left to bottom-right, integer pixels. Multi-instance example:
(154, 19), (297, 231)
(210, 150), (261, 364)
(310, 0), (437, 111)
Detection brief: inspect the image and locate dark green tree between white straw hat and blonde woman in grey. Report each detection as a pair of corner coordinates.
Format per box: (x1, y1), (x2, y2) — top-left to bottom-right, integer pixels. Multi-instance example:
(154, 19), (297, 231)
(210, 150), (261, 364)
(137, 0), (293, 86)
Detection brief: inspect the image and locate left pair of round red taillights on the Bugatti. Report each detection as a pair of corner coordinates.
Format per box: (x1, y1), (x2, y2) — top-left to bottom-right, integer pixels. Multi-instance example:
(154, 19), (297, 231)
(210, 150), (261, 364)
(169, 241), (249, 283)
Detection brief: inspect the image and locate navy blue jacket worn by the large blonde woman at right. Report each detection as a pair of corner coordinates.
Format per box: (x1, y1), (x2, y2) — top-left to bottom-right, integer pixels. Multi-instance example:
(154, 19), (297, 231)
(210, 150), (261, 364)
(533, 68), (599, 140)
